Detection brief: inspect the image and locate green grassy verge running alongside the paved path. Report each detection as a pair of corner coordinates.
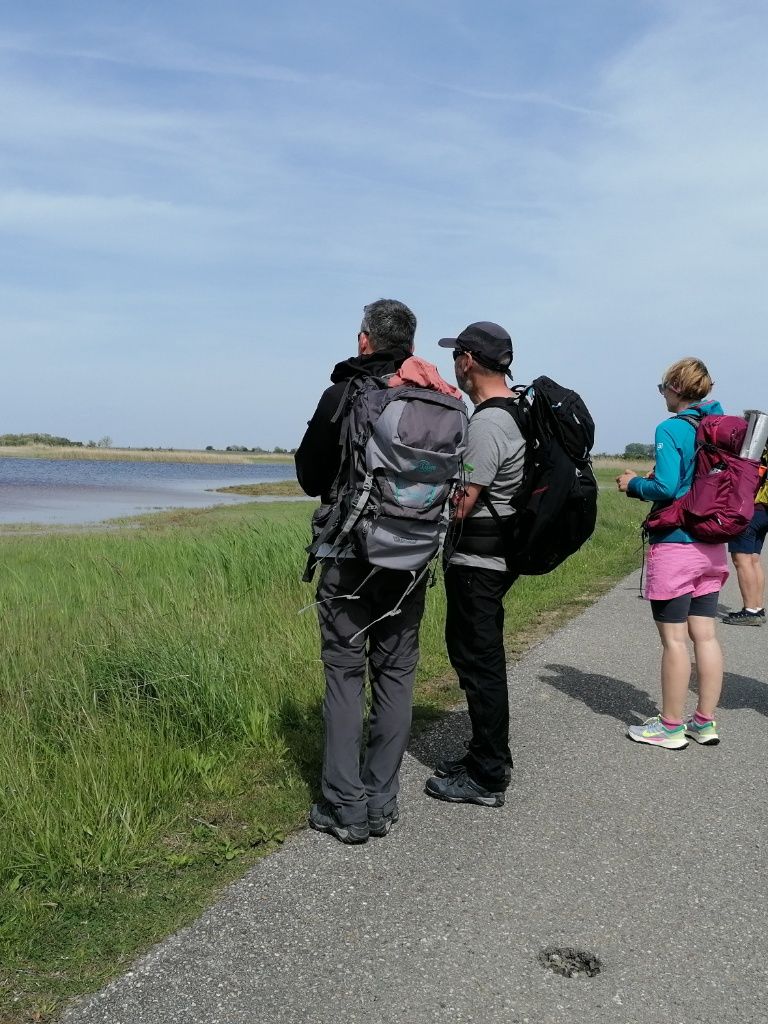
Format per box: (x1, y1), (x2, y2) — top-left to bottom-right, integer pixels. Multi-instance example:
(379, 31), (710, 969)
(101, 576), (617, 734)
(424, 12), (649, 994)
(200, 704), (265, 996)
(0, 493), (651, 1024)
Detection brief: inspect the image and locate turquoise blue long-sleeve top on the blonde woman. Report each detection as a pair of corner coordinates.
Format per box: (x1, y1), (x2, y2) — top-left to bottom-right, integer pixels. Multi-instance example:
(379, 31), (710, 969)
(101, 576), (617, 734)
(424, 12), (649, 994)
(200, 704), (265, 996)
(627, 401), (723, 544)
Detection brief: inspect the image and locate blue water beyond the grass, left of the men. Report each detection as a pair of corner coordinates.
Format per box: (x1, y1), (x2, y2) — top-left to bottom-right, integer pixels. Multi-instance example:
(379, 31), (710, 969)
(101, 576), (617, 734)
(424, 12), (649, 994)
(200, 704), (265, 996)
(0, 458), (296, 524)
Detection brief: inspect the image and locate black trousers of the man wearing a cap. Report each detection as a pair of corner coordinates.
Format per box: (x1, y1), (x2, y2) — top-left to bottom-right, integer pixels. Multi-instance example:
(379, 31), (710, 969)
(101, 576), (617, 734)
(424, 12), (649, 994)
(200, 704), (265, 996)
(445, 565), (517, 792)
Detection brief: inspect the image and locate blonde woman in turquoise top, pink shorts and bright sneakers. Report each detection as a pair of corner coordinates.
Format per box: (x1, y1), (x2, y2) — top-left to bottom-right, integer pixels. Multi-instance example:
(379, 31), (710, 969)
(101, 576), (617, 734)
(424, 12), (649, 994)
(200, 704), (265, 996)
(616, 357), (728, 750)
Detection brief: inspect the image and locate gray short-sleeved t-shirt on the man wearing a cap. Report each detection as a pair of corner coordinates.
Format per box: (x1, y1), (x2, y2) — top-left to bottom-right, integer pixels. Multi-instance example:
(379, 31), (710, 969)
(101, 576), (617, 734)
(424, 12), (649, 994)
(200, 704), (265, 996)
(451, 407), (525, 572)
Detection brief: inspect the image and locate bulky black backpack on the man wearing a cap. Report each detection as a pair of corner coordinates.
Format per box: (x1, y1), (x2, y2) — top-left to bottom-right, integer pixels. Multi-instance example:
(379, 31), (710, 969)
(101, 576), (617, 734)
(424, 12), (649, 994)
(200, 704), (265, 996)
(476, 377), (597, 575)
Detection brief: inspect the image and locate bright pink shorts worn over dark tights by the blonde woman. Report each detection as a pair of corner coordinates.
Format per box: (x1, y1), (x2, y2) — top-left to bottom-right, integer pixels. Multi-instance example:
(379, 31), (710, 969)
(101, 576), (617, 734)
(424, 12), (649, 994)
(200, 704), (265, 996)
(643, 542), (728, 601)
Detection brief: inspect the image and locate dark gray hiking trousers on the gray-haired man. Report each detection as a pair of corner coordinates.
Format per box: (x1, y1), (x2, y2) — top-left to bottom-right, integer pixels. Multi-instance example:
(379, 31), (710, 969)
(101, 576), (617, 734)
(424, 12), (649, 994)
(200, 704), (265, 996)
(317, 558), (427, 824)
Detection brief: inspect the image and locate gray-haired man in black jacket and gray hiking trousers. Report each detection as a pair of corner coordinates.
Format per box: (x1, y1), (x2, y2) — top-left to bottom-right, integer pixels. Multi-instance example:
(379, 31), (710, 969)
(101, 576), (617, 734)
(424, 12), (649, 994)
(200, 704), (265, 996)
(296, 299), (426, 843)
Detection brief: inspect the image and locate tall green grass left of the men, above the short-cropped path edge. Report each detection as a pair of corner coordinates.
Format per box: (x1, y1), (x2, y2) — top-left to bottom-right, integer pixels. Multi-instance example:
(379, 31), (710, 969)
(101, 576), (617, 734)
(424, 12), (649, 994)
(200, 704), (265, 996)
(0, 516), (321, 888)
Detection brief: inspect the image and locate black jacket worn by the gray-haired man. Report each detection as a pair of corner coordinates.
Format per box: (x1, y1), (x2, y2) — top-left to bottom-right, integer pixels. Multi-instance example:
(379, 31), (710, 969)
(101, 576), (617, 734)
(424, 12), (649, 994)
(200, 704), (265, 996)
(295, 351), (407, 505)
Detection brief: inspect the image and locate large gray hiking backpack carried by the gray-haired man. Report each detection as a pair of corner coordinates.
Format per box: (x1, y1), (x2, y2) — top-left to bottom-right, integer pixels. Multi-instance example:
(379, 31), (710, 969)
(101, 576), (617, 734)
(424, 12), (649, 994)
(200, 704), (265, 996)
(304, 376), (467, 582)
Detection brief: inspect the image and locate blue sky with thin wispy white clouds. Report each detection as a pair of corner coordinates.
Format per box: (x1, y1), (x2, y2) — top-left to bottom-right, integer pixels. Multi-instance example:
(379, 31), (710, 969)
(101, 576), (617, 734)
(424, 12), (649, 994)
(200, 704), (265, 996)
(0, 0), (768, 452)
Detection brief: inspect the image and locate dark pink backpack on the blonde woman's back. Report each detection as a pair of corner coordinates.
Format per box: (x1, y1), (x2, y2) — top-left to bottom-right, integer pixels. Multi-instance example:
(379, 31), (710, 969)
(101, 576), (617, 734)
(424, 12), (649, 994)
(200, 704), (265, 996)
(644, 415), (760, 544)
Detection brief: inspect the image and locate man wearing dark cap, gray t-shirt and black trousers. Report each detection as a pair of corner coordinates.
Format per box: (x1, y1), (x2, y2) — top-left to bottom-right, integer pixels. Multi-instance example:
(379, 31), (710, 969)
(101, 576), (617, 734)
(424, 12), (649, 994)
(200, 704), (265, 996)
(426, 322), (525, 807)
